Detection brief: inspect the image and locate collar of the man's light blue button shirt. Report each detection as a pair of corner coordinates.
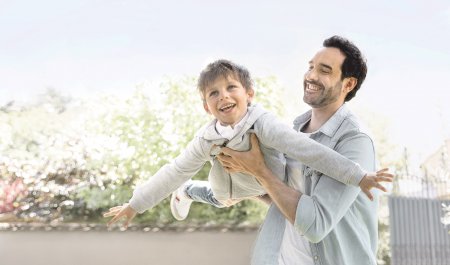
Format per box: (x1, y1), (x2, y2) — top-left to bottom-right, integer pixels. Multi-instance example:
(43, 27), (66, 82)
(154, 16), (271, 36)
(294, 104), (350, 138)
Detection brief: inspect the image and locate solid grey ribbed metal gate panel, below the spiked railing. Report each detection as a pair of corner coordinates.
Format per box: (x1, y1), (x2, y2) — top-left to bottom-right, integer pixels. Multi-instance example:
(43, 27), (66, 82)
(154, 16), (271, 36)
(388, 196), (450, 265)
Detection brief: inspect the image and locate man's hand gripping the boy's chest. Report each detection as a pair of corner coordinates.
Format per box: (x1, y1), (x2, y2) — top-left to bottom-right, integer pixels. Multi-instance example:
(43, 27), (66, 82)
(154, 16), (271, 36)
(217, 133), (268, 179)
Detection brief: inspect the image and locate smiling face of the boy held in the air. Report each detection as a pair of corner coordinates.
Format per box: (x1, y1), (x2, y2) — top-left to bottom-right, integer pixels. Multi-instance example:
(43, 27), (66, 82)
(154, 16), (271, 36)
(203, 76), (254, 126)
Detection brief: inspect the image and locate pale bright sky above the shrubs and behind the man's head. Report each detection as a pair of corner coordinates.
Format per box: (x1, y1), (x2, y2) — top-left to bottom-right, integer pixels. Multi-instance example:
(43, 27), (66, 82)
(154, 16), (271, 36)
(0, 0), (450, 163)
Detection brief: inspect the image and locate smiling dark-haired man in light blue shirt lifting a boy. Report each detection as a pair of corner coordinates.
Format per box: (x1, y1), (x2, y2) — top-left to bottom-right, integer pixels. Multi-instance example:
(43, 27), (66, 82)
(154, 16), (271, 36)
(219, 36), (384, 265)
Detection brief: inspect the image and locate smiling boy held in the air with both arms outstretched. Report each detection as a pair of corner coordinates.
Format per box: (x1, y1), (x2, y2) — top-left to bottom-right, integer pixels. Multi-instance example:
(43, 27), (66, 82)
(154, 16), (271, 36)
(104, 60), (392, 227)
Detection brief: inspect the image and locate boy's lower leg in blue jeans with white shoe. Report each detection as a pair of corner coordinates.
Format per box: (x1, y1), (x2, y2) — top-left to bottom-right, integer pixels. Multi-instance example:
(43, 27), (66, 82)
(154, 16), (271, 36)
(170, 180), (224, 221)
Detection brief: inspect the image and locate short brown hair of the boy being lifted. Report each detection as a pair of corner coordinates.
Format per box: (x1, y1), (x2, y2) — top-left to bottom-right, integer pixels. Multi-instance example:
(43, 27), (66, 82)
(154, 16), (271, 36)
(197, 59), (253, 98)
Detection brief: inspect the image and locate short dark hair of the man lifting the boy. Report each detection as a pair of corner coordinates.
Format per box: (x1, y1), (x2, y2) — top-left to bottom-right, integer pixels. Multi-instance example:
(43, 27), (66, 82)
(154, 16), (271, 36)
(323, 36), (367, 101)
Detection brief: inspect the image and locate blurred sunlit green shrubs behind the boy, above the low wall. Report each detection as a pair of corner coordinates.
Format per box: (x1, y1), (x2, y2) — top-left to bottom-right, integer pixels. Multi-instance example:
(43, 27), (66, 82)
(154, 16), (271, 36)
(0, 77), (282, 224)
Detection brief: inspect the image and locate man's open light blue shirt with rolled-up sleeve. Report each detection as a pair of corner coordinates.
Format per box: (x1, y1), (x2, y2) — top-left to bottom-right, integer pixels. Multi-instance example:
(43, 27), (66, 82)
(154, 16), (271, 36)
(252, 104), (378, 265)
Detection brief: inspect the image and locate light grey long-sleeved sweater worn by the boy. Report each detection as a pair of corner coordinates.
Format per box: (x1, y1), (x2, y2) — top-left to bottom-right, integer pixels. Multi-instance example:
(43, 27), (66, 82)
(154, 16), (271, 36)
(130, 105), (366, 213)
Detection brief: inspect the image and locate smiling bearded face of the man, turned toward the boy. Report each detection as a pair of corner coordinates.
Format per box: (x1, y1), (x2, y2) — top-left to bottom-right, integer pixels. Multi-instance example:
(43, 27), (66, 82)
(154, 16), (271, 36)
(303, 48), (348, 108)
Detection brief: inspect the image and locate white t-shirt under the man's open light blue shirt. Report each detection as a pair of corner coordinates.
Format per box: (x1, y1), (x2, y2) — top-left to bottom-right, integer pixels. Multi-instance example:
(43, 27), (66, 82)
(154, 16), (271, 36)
(278, 132), (314, 265)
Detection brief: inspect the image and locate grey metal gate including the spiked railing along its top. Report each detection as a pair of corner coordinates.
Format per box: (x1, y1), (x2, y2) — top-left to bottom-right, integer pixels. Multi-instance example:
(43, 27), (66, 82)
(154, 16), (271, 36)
(388, 176), (450, 265)
